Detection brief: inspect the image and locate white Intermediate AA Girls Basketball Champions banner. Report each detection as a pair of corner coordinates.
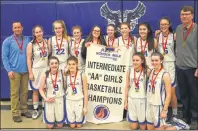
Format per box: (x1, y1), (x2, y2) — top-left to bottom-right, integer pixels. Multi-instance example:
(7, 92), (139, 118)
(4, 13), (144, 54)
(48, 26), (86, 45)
(85, 44), (131, 124)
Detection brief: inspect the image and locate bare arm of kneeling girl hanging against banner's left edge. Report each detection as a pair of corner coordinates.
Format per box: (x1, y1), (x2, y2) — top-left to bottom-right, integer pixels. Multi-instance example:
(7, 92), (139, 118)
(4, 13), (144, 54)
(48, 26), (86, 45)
(82, 74), (88, 115)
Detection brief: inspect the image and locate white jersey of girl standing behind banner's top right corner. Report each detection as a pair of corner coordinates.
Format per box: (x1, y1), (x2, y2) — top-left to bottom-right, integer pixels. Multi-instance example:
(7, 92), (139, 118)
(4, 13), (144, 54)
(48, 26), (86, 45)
(118, 36), (135, 55)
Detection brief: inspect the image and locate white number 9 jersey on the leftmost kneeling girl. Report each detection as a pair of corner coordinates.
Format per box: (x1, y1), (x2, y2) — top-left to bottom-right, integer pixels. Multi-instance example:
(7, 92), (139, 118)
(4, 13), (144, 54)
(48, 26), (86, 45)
(46, 70), (64, 97)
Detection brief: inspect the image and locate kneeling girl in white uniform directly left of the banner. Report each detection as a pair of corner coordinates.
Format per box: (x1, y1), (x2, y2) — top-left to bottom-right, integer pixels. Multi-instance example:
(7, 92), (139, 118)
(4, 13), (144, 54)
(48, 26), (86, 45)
(65, 56), (88, 128)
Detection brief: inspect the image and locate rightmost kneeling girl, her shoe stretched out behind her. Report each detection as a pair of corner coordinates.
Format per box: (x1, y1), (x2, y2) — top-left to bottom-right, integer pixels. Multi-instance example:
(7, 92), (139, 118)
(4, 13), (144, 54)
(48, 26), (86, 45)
(146, 52), (190, 130)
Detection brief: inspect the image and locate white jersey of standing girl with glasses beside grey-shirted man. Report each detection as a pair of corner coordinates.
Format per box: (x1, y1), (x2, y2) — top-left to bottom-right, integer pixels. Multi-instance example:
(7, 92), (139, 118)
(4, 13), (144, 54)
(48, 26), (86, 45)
(158, 33), (175, 61)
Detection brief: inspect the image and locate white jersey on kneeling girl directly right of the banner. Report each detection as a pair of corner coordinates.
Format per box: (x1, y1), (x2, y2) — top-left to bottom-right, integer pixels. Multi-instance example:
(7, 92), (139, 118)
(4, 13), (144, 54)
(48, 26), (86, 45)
(128, 68), (146, 98)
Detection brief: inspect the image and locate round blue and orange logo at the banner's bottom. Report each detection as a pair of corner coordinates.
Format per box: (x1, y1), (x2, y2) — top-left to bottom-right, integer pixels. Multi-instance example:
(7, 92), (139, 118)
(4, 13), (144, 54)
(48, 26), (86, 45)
(93, 105), (110, 120)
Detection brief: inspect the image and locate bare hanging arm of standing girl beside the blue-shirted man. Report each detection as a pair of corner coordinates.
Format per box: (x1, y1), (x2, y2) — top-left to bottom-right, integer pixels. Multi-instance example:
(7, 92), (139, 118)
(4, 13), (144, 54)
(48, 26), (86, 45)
(26, 42), (34, 80)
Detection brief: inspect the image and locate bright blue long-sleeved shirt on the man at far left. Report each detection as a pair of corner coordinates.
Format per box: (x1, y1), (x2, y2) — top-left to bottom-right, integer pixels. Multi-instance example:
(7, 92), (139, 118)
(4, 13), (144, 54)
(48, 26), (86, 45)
(2, 35), (30, 73)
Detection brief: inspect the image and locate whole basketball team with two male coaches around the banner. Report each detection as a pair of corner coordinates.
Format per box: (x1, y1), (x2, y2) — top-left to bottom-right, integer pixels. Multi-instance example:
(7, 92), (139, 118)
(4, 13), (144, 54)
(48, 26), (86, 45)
(2, 6), (198, 130)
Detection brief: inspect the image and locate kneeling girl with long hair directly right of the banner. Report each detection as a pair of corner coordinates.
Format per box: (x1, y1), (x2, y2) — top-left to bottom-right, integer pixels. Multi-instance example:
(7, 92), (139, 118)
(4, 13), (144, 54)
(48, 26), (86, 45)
(125, 52), (150, 130)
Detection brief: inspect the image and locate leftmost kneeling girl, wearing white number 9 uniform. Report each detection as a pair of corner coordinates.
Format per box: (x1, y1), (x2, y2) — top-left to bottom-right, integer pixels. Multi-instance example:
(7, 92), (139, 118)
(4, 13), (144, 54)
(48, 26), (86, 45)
(39, 56), (65, 129)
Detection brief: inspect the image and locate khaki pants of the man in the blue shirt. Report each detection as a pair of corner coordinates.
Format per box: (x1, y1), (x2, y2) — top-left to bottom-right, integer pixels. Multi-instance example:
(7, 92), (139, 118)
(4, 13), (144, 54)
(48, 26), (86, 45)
(10, 72), (28, 116)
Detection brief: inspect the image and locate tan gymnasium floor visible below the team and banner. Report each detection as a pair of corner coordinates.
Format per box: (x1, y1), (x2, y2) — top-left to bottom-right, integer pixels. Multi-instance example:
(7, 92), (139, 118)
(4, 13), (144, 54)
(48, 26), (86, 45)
(1, 101), (130, 130)
